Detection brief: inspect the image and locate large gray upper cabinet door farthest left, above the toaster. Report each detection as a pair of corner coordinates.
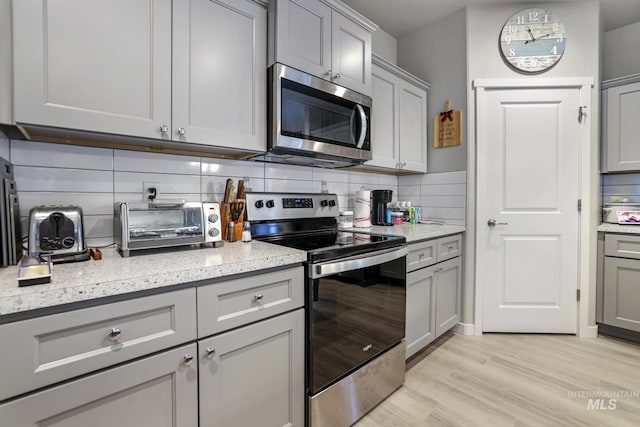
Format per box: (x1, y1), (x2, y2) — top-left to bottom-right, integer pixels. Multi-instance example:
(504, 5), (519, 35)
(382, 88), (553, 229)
(13, 0), (171, 138)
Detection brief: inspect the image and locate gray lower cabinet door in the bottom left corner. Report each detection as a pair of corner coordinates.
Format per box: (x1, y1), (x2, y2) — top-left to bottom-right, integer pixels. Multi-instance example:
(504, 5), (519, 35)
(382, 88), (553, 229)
(0, 344), (198, 427)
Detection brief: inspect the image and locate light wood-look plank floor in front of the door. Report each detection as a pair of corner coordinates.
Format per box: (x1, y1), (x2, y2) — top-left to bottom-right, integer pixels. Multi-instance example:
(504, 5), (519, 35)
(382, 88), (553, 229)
(356, 333), (640, 427)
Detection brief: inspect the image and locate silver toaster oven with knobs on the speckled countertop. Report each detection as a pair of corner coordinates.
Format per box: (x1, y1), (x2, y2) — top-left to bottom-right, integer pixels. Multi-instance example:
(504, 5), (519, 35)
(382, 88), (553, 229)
(114, 200), (222, 257)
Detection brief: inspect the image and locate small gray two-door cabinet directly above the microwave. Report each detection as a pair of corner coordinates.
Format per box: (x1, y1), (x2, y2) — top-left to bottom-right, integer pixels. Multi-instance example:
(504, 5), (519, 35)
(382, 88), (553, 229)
(269, 0), (377, 95)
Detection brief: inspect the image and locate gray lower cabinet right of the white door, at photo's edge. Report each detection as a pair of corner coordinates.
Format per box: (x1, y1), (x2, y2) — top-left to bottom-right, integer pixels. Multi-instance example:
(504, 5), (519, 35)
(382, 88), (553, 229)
(602, 234), (640, 332)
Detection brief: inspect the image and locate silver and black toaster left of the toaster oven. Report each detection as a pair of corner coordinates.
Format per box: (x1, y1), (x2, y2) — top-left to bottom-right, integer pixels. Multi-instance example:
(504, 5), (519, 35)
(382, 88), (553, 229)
(29, 206), (89, 263)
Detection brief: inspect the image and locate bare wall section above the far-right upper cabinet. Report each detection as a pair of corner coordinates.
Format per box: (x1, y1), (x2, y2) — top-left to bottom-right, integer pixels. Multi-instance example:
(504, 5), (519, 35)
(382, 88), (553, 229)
(602, 22), (640, 80)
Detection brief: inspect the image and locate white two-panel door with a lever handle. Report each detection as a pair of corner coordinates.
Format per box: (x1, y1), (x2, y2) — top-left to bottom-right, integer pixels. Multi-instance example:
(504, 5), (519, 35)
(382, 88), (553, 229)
(476, 87), (581, 333)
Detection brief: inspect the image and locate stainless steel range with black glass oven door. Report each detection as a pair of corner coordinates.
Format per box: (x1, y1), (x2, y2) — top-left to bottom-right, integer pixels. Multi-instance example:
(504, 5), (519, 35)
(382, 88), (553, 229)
(246, 193), (407, 427)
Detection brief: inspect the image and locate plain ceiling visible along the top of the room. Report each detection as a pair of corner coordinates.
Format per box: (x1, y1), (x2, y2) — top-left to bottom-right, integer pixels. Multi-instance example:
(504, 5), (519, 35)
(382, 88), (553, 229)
(343, 0), (640, 38)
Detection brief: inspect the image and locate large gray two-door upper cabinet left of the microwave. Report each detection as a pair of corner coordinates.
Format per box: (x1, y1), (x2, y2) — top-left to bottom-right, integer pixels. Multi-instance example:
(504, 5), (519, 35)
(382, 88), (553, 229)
(13, 0), (267, 151)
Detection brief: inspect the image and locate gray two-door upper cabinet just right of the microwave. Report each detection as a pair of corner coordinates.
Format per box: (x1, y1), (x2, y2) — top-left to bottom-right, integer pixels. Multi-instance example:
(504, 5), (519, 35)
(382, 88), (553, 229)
(365, 55), (429, 173)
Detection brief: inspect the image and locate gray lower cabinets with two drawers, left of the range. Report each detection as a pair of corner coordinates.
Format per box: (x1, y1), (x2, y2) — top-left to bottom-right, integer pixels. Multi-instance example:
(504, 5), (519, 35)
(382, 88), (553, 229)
(0, 266), (305, 427)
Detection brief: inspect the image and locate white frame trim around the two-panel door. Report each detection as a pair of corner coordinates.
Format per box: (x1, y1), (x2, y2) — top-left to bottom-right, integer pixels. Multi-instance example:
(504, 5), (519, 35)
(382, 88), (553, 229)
(465, 77), (599, 338)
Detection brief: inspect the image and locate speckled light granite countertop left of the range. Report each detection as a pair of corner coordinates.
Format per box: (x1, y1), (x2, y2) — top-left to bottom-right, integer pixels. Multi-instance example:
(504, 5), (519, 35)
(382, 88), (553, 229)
(0, 240), (307, 316)
